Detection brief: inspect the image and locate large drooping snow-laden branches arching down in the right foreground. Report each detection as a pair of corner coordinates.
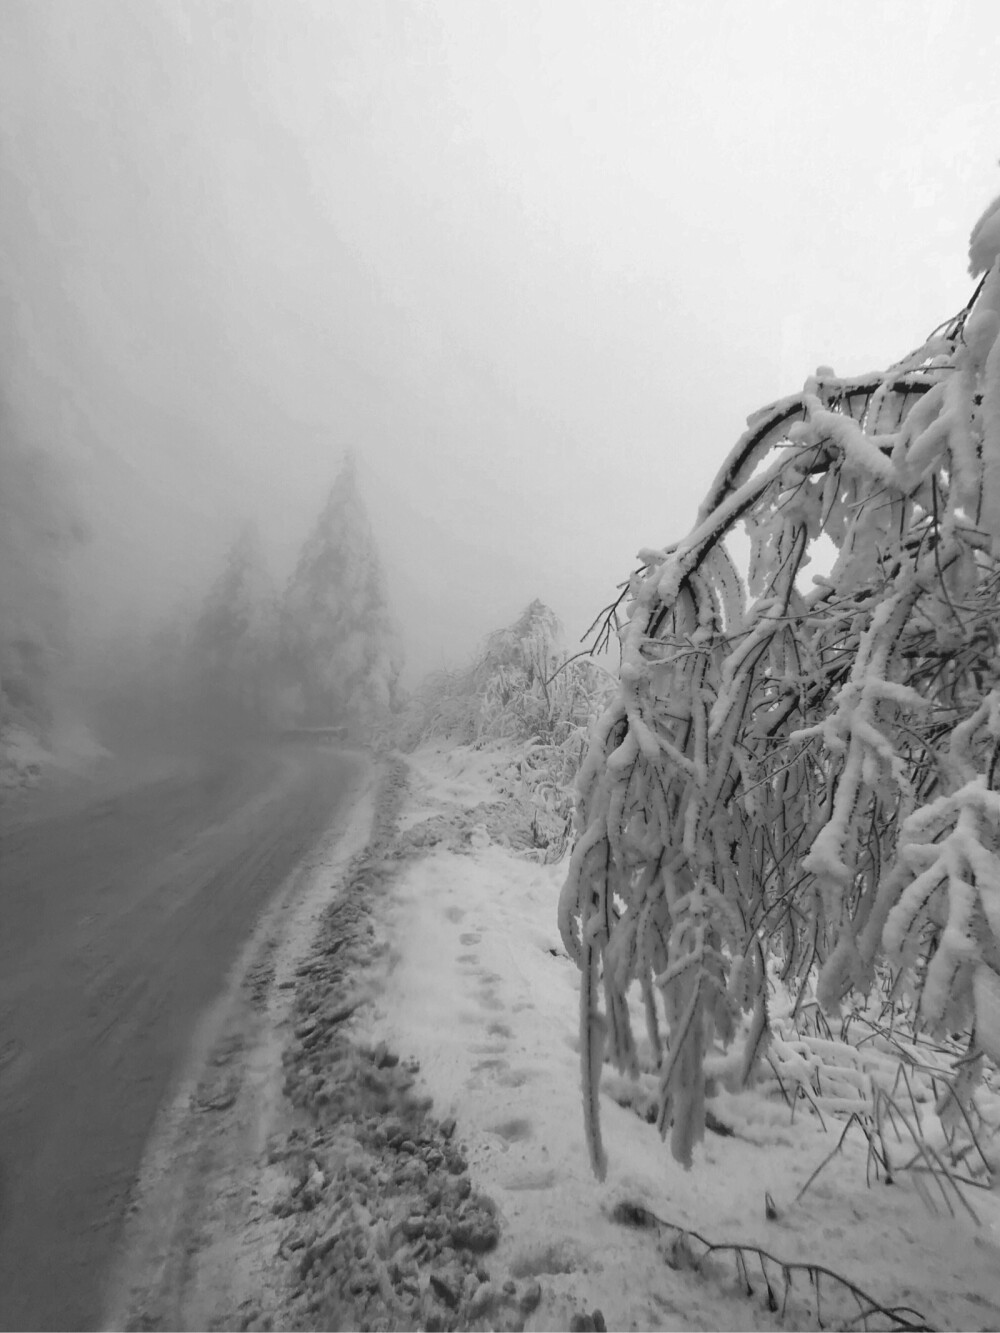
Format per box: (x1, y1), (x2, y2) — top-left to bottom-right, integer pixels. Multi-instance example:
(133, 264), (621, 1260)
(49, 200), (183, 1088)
(560, 193), (1000, 1174)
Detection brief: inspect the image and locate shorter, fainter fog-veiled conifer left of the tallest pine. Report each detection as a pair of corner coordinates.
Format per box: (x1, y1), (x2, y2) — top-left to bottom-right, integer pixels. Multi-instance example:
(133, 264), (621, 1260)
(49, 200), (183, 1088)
(191, 524), (275, 728)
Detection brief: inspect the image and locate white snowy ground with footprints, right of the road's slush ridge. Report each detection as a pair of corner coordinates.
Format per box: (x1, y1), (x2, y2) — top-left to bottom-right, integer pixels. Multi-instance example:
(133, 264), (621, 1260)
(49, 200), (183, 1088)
(365, 744), (1000, 1329)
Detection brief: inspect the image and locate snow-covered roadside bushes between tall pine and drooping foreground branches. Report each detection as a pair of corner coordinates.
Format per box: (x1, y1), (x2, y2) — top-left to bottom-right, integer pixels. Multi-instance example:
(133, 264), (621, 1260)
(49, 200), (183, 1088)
(403, 599), (613, 856)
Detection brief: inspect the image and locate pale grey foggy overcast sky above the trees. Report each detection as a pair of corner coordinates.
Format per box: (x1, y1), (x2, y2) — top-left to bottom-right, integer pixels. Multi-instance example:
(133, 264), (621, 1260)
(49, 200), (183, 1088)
(0, 0), (1000, 680)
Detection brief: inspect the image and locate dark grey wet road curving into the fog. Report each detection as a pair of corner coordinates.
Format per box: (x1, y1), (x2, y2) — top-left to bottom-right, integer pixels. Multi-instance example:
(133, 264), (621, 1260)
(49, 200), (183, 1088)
(0, 745), (359, 1329)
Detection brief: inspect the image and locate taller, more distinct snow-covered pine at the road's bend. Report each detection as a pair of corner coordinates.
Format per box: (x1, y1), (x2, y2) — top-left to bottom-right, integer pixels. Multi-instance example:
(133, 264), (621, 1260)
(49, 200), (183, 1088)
(280, 455), (403, 740)
